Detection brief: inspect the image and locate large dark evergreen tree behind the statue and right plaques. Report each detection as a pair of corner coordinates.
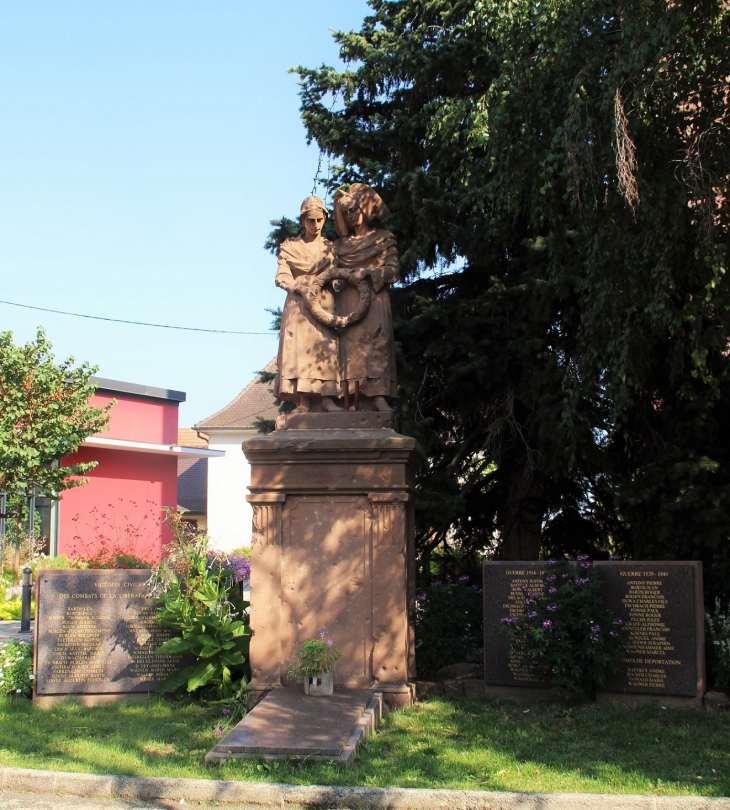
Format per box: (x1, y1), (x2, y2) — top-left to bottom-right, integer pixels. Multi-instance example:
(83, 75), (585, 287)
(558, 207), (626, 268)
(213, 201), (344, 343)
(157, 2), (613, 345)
(272, 0), (730, 568)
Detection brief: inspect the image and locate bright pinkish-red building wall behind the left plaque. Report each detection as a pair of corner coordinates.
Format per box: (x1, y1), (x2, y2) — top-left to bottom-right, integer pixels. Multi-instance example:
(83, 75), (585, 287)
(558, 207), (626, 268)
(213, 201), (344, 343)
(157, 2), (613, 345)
(56, 392), (183, 562)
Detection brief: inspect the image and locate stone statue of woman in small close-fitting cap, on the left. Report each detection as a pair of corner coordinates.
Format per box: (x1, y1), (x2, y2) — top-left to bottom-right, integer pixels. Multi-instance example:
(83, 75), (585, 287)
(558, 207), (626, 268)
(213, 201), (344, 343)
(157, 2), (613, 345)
(274, 197), (341, 413)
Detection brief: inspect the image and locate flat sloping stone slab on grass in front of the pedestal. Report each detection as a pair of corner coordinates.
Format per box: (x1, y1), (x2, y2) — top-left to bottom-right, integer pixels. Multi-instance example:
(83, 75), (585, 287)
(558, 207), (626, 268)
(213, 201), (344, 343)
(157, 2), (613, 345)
(205, 687), (383, 765)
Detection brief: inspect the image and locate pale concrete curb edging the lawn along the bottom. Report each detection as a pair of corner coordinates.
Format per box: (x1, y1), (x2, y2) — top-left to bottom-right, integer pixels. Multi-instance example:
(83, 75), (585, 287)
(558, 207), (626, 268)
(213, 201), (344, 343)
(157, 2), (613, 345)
(0, 767), (730, 810)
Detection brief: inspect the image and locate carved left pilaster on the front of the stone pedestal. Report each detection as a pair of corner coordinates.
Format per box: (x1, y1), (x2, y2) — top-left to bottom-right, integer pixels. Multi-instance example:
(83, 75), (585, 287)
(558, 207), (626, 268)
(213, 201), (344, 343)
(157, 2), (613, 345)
(246, 492), (286, 692)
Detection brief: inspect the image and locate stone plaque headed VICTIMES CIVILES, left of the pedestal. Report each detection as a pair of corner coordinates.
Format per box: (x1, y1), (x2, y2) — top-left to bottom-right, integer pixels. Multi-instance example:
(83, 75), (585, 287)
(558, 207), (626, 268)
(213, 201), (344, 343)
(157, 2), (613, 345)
(35, 569), (189, 696)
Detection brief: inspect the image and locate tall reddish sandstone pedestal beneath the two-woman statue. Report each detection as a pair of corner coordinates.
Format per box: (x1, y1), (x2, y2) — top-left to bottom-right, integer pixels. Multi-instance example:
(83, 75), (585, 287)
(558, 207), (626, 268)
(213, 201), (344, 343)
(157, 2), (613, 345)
(243, 412), (423, 705)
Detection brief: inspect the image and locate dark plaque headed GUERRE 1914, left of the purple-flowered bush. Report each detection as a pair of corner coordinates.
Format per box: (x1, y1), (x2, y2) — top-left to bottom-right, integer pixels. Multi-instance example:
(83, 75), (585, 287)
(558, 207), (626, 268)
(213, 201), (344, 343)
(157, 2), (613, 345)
(484, 562), (550, 687)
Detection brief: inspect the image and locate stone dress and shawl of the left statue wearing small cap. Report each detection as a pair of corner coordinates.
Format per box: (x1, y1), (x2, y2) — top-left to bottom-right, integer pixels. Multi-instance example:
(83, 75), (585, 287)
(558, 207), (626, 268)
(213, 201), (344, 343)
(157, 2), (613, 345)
(274, 236), (340, 402)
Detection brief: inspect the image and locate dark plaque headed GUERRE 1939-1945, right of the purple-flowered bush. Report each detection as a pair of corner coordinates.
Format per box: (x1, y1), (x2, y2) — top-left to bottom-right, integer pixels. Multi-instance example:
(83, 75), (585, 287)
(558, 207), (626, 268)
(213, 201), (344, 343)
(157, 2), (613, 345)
(596, 562), (705, 697)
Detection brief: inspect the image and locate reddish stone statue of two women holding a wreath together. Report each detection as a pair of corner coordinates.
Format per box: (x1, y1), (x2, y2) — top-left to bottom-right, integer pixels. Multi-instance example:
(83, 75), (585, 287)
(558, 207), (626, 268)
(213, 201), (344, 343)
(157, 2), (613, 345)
(274, 183), (400, 413)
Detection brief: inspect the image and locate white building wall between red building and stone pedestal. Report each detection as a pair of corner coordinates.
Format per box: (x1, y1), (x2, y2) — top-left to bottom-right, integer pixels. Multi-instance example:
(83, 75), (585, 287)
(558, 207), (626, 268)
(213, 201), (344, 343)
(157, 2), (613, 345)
(208, 430), (259, 551)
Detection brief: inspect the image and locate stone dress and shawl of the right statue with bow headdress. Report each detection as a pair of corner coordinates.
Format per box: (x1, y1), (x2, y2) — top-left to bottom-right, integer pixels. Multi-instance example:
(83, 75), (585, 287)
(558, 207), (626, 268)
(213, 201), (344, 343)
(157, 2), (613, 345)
(335, 228), (400, 397)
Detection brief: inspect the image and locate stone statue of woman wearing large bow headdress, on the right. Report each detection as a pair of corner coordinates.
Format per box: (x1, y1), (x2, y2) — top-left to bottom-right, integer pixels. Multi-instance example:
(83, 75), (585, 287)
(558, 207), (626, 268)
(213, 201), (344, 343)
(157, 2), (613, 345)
(335, 183), (400, 411)
